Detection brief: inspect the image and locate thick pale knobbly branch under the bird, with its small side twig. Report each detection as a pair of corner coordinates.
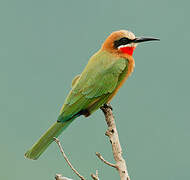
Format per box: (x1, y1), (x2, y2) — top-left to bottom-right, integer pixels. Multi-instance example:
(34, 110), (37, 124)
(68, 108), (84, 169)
(99, 104), (130, 180)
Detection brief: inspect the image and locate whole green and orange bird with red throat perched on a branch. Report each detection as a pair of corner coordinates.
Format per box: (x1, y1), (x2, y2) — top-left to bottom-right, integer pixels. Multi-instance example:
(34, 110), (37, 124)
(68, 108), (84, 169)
(25, 30), (159, 160)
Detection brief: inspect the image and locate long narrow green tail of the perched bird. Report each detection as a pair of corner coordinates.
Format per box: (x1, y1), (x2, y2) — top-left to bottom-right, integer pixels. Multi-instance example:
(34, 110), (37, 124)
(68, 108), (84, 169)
(25, 118), (75, 160)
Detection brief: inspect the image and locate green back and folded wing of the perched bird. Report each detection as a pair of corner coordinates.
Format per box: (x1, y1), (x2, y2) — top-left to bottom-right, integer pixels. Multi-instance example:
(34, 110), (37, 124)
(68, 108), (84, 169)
(59, 51), (128, 121)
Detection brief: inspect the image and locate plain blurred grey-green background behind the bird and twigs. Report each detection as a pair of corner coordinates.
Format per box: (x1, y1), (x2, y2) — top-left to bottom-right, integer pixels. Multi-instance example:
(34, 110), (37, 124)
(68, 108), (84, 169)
(0, 0), (190, 180)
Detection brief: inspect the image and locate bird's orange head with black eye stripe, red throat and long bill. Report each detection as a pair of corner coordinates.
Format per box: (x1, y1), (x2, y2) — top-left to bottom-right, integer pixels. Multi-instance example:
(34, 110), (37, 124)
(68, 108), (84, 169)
(102, 30), (159, 56)
